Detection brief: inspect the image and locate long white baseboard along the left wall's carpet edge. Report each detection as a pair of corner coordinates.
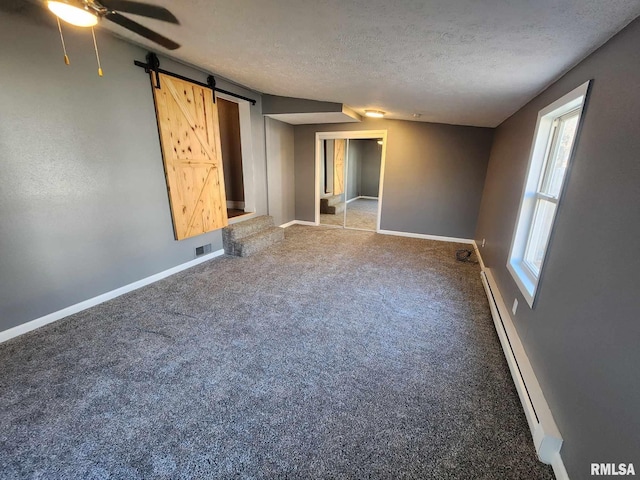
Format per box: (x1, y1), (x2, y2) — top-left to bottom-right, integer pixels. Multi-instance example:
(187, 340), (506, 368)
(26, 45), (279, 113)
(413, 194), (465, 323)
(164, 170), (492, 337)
(0, 250), (224, 343)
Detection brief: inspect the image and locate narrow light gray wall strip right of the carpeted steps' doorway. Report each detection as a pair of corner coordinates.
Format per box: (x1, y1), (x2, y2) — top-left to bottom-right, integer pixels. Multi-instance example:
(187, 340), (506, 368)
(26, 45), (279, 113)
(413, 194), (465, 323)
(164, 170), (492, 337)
(264, 117), (295, 225)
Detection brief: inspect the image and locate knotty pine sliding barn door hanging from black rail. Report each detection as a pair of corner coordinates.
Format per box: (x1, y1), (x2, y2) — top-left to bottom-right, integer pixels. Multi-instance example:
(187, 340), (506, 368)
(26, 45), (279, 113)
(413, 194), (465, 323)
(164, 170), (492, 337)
(151, 74), (228, 240)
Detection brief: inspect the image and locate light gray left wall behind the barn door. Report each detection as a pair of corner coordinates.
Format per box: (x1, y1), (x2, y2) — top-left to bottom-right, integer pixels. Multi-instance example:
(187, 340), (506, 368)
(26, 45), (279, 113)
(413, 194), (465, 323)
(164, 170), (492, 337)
(0, 4), (267, 330)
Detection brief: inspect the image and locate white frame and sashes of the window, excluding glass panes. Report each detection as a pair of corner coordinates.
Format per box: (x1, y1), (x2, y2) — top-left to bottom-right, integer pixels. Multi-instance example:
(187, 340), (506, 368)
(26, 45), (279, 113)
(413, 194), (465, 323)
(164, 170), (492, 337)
(507, 80), (591, 308)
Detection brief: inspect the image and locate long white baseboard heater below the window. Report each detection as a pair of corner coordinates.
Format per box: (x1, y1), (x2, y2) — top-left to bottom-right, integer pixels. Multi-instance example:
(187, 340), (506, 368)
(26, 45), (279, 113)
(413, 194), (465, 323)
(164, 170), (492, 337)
(480, 269), (566, 468)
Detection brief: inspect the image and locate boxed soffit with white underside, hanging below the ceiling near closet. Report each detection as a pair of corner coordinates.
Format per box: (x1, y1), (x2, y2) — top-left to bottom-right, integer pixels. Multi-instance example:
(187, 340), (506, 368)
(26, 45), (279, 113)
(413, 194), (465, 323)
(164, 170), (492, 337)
(262, 95), (362, 125)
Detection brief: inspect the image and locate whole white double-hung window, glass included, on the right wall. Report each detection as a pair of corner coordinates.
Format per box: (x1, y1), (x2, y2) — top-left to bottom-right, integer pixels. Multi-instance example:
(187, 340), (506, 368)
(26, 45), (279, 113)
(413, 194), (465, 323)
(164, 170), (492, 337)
(507, 82), (589, 307)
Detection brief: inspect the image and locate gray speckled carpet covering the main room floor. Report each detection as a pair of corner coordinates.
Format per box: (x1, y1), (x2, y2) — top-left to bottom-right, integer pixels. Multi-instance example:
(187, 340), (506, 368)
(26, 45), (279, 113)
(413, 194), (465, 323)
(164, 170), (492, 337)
(0, 226), (553, 480)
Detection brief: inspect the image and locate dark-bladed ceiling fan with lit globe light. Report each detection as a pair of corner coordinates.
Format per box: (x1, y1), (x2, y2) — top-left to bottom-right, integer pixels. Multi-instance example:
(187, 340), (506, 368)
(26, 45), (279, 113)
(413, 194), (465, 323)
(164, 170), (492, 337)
(47, 0), (180, 50)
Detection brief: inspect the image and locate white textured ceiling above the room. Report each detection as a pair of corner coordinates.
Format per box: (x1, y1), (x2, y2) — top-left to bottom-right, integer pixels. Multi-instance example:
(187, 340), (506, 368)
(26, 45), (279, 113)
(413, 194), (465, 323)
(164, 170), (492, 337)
(95, 0), (640, 126)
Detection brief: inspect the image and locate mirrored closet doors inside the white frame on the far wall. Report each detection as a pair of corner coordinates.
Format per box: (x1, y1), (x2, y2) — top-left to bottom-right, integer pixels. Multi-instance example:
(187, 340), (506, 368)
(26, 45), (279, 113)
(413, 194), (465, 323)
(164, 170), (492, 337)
(317, 138), (383, 232)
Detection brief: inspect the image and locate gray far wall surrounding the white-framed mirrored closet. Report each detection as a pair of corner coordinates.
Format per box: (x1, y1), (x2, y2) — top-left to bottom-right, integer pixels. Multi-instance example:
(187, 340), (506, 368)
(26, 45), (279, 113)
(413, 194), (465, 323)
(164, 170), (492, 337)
(295, 119), (493, 238)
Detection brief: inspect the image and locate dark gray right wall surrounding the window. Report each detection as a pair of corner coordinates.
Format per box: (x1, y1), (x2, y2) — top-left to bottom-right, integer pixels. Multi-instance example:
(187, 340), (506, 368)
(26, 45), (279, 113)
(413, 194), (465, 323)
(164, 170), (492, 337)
(475, 15), (640, 479)
